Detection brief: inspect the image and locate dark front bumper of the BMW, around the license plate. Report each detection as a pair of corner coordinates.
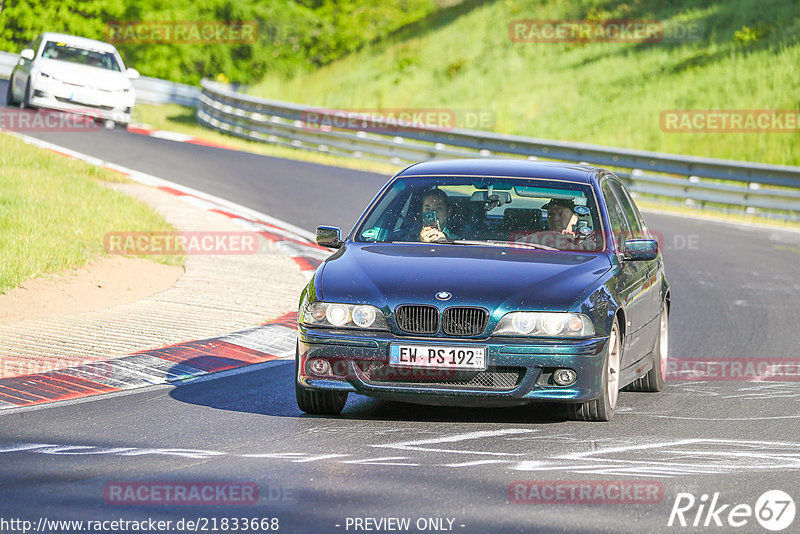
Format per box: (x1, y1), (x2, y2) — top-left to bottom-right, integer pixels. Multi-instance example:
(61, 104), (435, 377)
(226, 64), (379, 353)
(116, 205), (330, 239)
(296, 326), (608, 406)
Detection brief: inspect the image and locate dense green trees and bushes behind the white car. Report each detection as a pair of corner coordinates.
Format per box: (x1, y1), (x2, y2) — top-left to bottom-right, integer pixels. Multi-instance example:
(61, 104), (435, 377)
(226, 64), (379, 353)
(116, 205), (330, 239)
(0, 0), (436, 84)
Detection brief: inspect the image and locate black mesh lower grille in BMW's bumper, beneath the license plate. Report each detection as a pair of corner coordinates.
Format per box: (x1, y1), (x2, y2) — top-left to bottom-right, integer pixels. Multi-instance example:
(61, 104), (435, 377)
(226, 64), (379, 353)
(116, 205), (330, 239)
(359, 362), (525, 391)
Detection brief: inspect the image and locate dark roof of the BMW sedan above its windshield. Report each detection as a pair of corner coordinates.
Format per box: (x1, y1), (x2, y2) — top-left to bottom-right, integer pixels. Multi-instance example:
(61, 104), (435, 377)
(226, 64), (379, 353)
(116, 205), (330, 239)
(398, 158), (603, 184)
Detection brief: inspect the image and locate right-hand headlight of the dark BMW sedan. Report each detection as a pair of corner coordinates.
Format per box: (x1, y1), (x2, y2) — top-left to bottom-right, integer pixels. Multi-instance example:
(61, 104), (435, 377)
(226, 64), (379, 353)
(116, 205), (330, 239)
(494, 312), (594, 337)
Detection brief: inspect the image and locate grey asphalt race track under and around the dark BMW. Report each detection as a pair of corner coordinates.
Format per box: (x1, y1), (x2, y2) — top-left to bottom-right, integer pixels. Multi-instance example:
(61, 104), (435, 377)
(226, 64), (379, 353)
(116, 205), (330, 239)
(0, 84), (800, 533)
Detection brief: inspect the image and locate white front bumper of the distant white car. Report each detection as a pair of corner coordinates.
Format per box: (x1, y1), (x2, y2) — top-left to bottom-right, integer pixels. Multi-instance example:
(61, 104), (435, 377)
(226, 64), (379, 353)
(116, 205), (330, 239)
(30, 80), (135, 124)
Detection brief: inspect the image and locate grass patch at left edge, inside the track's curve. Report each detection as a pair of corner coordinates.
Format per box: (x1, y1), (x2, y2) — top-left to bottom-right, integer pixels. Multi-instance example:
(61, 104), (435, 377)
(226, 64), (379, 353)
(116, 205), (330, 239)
(0, 134), (183, 293)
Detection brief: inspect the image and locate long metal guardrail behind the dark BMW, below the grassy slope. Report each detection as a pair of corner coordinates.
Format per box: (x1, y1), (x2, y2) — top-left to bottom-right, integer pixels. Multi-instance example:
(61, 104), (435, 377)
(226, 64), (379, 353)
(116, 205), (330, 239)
(197, 80), (800, 220)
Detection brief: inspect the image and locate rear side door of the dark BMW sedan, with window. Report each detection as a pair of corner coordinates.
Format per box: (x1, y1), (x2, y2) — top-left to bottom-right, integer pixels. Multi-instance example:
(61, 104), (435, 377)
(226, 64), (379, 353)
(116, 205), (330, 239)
(611, 180), (661, 354)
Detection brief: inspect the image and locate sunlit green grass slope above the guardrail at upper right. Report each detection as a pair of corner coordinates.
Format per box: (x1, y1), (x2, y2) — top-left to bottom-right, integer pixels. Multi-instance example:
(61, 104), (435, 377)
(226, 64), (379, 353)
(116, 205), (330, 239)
(249, 0), (800, 165)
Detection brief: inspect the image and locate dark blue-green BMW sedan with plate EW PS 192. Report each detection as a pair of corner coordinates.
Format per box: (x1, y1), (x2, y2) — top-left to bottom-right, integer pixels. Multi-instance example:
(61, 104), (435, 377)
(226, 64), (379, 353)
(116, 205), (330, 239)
(295, 159), (670, 421)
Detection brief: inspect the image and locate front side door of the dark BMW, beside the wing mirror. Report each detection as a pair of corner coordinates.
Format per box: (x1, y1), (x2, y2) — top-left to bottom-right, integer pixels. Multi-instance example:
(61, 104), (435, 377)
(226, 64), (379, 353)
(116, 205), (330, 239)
(601, 177), (649, 368)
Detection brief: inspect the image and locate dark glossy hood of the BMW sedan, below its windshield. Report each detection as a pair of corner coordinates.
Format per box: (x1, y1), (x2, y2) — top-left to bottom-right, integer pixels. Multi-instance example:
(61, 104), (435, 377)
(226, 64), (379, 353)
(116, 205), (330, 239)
(315, 243), (611, 312)
